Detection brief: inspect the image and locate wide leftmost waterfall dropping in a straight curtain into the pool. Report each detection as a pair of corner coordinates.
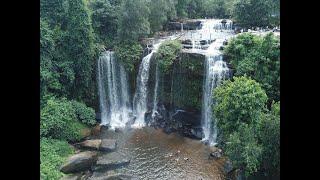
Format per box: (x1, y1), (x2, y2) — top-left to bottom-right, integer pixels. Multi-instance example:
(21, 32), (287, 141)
(98, 51), (132, 128)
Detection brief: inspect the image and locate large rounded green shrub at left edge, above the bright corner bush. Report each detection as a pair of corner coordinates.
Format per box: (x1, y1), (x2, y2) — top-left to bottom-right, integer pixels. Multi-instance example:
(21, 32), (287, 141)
(40, 97), (86, 141)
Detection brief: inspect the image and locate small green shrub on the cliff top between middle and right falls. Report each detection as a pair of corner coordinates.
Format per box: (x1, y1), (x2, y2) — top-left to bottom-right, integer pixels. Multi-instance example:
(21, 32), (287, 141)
(156, 40), (182, 73)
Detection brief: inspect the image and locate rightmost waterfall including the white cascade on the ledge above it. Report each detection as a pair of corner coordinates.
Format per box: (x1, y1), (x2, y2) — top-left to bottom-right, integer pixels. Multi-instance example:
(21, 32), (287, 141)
(201, 20), (232, 145)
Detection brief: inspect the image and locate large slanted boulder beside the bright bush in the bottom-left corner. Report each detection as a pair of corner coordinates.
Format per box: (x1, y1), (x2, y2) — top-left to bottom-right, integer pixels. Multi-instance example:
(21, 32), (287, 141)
(60, 151), (97, 174)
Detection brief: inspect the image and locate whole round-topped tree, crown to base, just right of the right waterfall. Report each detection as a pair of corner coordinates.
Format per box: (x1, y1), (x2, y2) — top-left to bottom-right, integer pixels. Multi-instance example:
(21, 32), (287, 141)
(213, 76), (267, 176)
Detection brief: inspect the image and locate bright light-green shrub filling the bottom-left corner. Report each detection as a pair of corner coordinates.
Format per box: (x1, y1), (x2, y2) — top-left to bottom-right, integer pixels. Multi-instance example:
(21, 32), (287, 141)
(40, 138), (74, 180)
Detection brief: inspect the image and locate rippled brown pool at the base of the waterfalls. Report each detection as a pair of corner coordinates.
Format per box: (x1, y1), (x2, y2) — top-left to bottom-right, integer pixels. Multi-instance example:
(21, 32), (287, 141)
(100, 127), (224, 180)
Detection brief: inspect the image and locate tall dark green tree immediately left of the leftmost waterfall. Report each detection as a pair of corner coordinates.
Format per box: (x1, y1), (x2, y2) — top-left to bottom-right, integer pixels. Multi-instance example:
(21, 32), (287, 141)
(63, 0), (95, 102)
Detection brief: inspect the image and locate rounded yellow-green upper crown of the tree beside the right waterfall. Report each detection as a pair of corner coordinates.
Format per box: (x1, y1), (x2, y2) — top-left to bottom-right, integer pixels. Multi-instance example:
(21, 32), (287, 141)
(213, 76), (267, 135)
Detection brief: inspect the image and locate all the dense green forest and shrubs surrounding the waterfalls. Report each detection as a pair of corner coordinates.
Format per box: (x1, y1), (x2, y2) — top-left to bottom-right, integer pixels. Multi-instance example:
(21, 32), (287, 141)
(40, 0), (280, 179)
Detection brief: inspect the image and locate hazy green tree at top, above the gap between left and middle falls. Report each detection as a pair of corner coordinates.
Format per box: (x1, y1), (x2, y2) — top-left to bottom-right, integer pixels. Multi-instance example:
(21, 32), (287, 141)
(118, 0), (150, 41)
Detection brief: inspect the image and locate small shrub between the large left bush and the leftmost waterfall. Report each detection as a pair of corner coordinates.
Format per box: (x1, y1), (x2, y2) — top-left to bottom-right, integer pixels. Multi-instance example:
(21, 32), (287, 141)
(72, 101), (96, 126)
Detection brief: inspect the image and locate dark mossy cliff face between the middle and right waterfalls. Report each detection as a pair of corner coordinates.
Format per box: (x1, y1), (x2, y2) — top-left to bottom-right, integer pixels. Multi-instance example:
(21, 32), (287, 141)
(146, 53), (205, 139)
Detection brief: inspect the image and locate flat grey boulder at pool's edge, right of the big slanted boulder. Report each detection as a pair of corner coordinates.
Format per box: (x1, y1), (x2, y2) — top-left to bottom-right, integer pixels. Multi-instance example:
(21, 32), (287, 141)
(94, 152), (130, 171)
